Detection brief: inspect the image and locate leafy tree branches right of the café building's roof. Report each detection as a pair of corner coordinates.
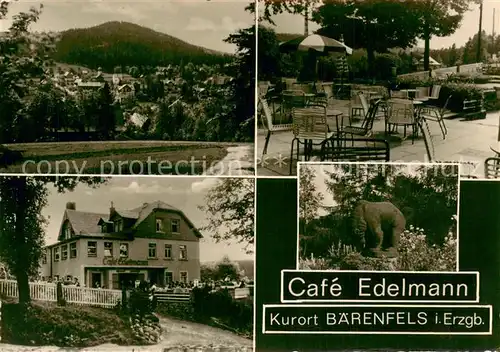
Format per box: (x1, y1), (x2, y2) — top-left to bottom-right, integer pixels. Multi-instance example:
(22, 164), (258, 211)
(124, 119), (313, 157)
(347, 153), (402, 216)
(199, 178), (255, 253)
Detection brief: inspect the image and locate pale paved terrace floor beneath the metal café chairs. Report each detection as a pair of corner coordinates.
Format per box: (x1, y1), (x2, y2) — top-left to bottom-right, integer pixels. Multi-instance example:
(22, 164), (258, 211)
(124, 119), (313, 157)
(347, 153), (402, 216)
(257, 100), (500, 178)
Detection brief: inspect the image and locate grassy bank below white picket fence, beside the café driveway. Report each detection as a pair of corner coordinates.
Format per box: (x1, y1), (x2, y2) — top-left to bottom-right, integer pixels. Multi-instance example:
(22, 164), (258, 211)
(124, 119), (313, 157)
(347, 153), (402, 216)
(2, 302), (143, 347)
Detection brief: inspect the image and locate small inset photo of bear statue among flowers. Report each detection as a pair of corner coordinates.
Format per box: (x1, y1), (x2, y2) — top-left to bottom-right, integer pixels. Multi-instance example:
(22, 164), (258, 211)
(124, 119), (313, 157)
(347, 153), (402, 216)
(297, 163), (460, 272)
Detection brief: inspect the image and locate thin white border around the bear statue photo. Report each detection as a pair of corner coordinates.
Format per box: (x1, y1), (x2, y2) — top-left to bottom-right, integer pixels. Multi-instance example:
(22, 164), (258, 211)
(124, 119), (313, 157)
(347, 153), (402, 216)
(296, 161), (460, 272)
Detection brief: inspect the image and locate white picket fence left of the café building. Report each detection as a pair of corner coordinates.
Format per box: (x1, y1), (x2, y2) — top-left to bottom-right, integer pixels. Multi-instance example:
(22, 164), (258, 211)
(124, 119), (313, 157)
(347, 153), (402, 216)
(0, 280), (122, 308)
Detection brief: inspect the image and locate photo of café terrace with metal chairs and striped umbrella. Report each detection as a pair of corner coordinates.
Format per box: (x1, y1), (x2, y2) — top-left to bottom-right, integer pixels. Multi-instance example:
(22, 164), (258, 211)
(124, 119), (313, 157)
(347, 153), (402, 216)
(256, 0), (500, 179)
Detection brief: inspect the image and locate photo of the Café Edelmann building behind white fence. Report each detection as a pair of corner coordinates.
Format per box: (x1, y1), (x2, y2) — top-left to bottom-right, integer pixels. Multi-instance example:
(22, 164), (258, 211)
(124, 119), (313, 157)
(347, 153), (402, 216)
(0, 174), (255, 352)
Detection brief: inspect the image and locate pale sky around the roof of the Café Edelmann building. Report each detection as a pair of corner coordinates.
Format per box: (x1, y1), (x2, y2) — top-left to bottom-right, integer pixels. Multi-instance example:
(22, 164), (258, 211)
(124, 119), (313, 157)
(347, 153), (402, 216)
(42, 176), (253, 262)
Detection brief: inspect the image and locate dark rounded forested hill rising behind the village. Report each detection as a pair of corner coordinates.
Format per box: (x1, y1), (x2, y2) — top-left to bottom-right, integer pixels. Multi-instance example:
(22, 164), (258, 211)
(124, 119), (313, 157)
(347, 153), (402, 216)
(54, 22), (230, 72)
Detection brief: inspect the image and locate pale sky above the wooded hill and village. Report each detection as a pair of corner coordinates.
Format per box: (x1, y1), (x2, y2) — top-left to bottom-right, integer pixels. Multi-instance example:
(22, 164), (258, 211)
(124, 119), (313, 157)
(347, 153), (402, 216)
(0, 0), (255, 53)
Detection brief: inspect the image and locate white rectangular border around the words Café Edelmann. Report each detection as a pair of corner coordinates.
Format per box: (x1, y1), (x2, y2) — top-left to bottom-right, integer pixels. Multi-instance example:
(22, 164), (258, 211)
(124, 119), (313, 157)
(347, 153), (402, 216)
(280, 269), (480, 306)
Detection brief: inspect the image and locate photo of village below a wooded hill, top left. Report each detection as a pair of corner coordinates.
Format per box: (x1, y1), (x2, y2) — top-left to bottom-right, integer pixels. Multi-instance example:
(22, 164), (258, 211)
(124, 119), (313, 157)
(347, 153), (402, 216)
(0, 0), (256, 176)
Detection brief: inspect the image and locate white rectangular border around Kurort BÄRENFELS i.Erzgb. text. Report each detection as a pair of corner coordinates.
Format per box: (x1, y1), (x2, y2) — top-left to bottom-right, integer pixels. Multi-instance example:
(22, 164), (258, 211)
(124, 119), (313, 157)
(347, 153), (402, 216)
(262, 304), (493, 335)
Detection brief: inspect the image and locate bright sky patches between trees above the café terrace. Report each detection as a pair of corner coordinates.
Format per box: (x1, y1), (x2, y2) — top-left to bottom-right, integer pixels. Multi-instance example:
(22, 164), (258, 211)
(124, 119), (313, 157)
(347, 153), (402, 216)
(262, 0), (500, 49)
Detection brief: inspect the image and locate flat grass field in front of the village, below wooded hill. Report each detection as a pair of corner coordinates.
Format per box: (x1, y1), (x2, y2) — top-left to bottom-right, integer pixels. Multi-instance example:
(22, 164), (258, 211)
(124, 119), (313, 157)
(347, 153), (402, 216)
(0, 141), (235, 175)
